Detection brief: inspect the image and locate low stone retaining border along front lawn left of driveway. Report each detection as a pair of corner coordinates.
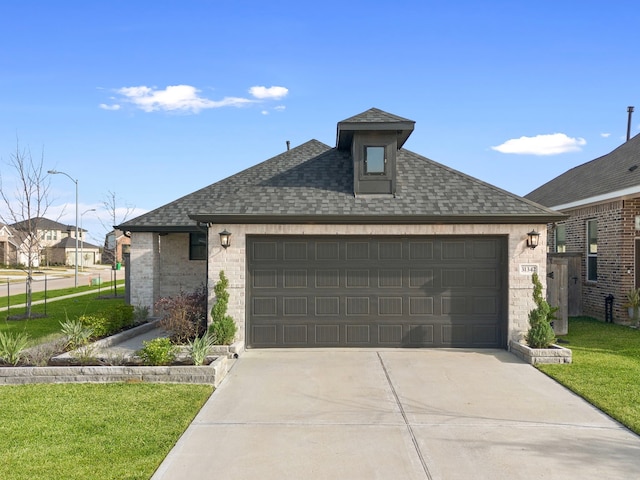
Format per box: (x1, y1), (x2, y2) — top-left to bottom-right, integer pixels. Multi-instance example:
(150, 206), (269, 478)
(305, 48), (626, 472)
(0, 356), (233, 387)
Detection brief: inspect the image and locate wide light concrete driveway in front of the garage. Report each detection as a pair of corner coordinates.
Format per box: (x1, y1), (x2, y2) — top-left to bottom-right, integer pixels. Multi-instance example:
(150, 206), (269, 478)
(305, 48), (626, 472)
(153, 349), (640, 480)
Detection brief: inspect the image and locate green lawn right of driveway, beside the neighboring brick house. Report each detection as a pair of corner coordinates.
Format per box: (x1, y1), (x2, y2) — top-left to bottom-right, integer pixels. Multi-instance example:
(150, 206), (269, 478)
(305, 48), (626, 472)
(539, 317), (640, 434)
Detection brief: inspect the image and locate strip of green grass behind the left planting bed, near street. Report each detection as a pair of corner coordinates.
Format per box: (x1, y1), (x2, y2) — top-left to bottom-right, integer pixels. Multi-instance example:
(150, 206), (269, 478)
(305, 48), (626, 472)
(0, 287), (124, 345)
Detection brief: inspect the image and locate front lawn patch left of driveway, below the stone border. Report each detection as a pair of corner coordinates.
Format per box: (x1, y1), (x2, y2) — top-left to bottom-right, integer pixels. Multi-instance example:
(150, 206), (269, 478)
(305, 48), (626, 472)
(0, 383), (213, 480)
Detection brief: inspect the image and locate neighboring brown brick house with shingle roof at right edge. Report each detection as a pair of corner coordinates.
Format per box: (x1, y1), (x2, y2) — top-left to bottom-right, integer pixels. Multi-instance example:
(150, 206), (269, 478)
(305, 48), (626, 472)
(525, 136), (640, 321)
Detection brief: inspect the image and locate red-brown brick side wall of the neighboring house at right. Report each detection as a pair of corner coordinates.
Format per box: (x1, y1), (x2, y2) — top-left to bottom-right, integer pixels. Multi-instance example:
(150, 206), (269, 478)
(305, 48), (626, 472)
(548, 198), (640, 322)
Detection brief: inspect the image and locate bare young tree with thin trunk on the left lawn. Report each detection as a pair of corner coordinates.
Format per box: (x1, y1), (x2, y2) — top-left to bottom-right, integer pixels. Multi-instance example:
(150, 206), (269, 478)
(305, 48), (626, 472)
(0, 141), (51, 318)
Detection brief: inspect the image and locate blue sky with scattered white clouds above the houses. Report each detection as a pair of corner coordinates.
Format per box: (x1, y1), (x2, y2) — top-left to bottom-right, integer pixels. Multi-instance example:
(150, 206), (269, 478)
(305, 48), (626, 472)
(0, 0), (640, 243)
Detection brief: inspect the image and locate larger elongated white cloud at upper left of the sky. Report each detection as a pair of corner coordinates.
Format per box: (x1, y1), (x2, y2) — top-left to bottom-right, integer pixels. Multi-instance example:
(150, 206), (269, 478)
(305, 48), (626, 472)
(118, 85), (252, 113)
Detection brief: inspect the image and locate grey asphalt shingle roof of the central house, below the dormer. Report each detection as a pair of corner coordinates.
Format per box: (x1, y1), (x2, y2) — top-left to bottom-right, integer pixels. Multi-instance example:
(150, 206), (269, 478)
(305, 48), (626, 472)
(118, 133), (559, 231)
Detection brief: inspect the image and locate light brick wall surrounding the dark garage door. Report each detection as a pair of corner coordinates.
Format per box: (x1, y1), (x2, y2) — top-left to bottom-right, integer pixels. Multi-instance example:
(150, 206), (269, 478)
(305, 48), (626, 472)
(208, 224), (547, 341)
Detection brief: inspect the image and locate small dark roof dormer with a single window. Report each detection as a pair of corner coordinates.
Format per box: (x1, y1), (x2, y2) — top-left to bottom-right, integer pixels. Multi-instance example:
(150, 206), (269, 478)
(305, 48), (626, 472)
(336, 108), (415, 195)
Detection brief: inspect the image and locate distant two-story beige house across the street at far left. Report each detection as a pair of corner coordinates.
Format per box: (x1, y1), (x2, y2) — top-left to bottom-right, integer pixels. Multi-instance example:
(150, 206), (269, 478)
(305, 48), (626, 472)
(11, 217), (101, 266)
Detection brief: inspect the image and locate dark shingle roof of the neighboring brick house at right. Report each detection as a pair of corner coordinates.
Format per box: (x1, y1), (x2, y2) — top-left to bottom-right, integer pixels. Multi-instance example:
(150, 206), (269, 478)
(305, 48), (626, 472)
(525, 135), (640, 207)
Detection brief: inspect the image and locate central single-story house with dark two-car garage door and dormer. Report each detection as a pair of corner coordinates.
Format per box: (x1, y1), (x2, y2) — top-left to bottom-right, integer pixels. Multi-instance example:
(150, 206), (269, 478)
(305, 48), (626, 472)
(117, 109), (564, 348)
